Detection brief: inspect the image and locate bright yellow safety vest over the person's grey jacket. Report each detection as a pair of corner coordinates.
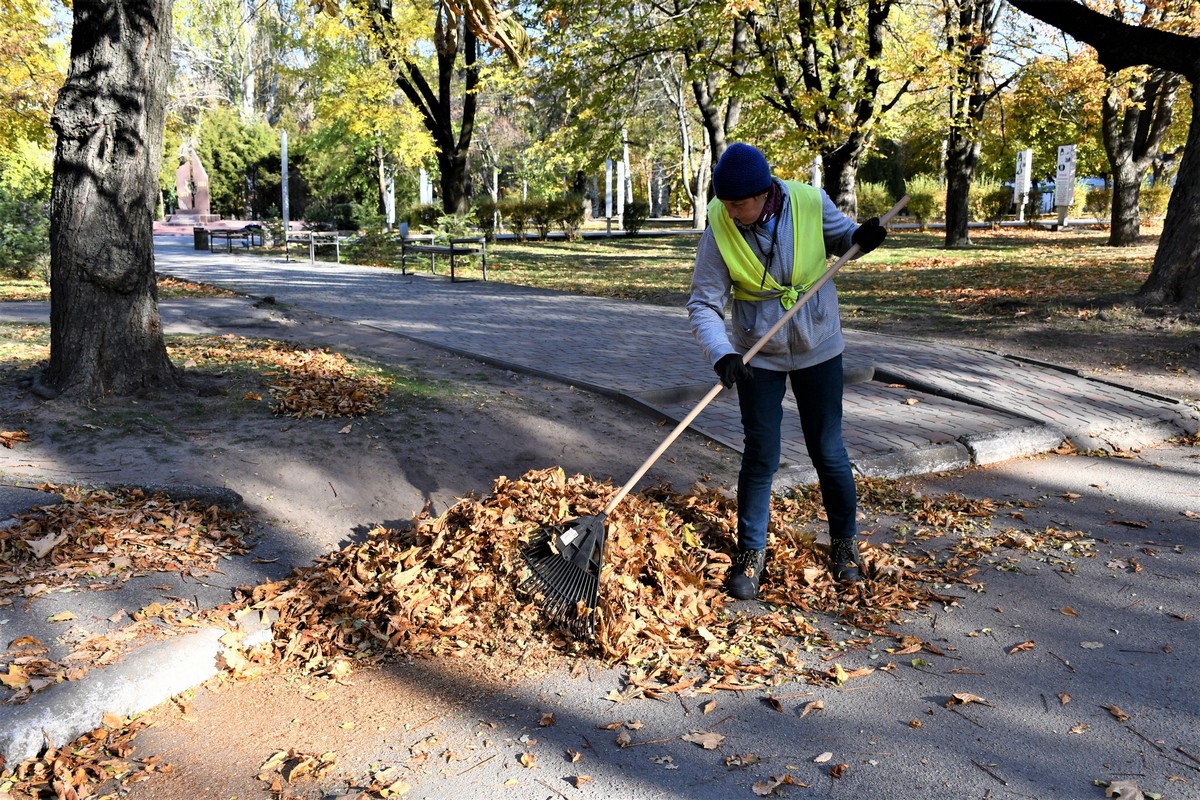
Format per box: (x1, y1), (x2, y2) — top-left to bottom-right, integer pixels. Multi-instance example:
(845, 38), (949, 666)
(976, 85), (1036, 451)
(708, 181), (826, 308)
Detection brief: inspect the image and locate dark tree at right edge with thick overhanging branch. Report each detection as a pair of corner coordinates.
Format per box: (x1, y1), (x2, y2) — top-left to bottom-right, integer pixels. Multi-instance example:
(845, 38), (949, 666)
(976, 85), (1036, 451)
(1010, 0), (1200, 309)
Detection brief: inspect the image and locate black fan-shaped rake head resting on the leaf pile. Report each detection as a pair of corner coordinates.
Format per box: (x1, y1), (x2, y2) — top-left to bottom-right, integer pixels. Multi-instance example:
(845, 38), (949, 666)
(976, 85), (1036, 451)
(520, 515), (605, 638)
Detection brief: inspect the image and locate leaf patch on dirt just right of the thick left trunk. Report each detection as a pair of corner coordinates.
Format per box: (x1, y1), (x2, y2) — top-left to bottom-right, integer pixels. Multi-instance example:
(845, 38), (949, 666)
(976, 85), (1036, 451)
(172, 335), (390, 419)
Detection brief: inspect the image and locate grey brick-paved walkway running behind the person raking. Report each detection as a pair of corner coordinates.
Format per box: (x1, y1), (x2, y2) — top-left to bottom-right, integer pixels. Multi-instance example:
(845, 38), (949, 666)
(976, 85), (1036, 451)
(138, 236), (1200, 485)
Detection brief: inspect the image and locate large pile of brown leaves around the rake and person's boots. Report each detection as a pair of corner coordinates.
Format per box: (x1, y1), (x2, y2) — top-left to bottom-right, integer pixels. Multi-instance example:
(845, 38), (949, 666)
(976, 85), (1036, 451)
(246, 469), (993, 694)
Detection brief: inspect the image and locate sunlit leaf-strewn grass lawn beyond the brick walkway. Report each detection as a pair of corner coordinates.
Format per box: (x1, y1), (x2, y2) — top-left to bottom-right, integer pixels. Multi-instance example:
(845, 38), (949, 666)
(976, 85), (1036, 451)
(488, 221), (1157, 329)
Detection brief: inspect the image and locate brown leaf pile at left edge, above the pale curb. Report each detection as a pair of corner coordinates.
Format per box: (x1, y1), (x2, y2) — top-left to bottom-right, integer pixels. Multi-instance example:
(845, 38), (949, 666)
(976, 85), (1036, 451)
(0, 486), (248, 606)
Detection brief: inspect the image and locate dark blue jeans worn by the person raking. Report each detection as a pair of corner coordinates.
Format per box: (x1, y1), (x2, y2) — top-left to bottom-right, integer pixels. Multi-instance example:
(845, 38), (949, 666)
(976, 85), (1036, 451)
(738, 355), (858, 551)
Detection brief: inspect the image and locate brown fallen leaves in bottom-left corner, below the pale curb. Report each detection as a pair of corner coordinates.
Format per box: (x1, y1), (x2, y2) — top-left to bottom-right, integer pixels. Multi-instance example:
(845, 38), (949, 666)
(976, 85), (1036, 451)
(0, 714), (170, 798)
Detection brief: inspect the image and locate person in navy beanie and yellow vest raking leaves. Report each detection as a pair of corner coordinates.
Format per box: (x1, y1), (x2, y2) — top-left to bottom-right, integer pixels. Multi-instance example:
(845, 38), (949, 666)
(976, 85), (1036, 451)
(688, 143), (887, 600)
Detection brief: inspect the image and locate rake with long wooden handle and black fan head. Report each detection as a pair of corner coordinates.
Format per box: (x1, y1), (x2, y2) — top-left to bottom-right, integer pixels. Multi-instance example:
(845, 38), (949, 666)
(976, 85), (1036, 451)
(518, 196), (908, 638)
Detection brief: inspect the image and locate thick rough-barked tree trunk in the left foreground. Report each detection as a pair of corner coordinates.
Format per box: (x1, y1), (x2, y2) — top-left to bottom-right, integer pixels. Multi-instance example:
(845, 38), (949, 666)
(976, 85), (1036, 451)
(46, 0), (178, 398)
